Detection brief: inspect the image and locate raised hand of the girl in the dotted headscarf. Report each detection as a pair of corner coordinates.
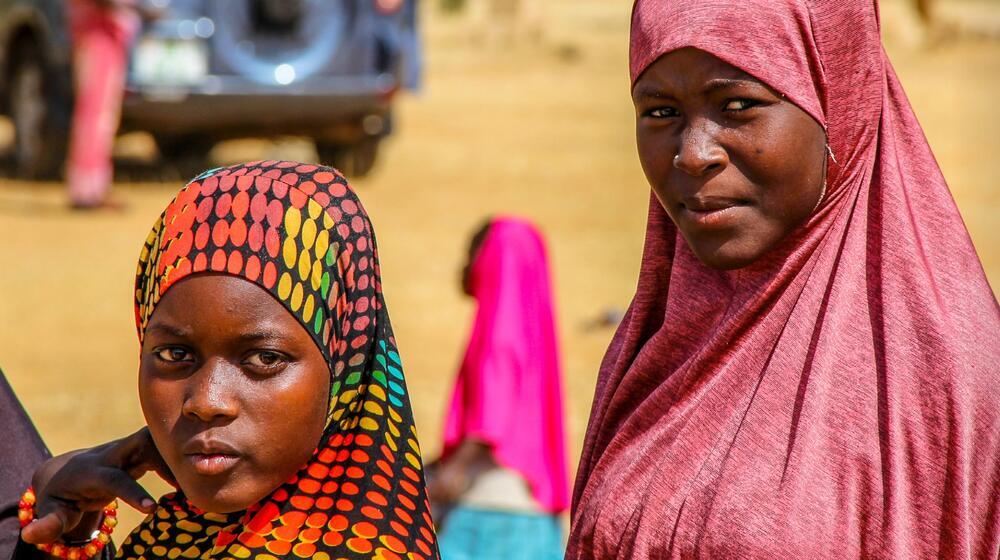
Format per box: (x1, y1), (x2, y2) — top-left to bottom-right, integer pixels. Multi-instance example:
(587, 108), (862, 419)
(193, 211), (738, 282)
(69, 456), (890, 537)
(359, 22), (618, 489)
(21, 428), (177, 544)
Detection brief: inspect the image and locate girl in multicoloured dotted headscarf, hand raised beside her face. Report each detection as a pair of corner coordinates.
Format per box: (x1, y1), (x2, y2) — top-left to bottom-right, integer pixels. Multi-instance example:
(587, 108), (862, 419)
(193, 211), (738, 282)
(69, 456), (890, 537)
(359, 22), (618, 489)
(22, 162), (438, 560)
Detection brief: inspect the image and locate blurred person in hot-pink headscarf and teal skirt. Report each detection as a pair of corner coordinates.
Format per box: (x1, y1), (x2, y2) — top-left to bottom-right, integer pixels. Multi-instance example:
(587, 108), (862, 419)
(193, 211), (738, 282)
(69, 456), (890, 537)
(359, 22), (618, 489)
(429, 218), (569, 560)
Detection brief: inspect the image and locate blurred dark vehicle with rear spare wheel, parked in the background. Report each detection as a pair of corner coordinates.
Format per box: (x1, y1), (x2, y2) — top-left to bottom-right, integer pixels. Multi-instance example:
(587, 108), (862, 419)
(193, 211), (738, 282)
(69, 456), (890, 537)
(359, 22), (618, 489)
(0, 0), (420, 178)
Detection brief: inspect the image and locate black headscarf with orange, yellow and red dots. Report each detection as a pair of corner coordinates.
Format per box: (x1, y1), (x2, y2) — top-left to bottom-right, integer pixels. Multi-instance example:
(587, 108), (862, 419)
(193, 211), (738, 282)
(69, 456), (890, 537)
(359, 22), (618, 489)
(119, 161), (439, 560)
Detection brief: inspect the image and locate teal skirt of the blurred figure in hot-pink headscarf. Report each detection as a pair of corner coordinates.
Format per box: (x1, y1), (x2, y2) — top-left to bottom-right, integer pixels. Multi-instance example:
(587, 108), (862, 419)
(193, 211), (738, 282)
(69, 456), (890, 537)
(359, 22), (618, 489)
(438, 506), (565, 560)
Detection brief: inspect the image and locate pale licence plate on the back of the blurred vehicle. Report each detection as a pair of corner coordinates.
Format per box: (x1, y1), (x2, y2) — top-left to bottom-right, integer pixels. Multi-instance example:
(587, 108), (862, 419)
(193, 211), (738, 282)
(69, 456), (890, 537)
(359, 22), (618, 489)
(133, 37), (208, 87)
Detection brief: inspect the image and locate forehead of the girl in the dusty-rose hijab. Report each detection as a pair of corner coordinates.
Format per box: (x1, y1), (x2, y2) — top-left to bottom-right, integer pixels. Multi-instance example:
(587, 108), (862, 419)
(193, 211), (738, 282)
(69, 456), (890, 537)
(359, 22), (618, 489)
(632, 47), (764, 99)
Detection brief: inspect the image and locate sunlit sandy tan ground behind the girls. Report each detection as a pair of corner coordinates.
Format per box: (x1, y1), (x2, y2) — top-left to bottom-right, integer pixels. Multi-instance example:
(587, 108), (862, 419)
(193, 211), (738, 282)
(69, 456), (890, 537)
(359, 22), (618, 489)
(0, 0), (1000, 523)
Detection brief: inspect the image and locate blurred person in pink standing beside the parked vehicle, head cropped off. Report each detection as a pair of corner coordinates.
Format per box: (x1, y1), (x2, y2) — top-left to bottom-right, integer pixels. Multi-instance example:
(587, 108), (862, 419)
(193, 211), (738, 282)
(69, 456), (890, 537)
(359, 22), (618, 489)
(66, 0), (139, 208)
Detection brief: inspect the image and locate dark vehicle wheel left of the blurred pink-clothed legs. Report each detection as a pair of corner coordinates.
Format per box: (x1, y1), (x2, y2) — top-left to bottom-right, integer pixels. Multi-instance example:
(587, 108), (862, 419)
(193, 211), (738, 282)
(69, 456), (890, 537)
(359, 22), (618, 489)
(7, 41), (73, 180)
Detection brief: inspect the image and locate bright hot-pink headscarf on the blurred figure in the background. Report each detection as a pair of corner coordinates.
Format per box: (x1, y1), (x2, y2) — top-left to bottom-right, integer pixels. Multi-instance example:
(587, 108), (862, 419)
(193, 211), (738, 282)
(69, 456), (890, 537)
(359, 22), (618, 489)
(444, 218), (569, 513)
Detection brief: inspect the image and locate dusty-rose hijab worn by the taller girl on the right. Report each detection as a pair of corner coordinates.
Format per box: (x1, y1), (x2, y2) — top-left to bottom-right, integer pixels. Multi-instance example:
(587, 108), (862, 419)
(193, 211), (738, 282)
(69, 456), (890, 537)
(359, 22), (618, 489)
(567, 0), (1000, 560)
